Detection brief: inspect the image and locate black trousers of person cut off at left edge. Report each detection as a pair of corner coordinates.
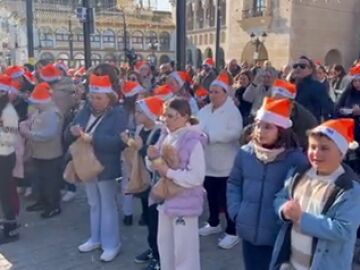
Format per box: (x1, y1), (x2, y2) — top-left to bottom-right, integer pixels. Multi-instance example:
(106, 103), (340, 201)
(0, 153), (17, 221)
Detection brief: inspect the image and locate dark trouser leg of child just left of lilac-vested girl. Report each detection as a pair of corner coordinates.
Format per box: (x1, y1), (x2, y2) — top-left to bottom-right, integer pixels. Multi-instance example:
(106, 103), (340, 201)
(147, 204), (160, 261)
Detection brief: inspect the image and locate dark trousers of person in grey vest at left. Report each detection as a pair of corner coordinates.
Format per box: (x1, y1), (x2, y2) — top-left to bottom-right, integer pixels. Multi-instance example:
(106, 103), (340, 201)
(33, 157), (62, 210)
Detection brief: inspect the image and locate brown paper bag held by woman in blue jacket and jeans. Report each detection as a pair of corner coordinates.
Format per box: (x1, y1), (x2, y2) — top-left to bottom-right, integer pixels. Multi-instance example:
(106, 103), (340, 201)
(69, 138), (104, 182)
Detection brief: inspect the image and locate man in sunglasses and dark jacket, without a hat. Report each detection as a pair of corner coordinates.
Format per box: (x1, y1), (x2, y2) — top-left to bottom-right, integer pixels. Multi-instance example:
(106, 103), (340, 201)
(293, 56), (334, 121)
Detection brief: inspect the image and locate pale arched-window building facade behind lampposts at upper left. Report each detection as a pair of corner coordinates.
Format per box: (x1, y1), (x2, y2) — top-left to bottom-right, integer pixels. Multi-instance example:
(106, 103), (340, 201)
(3, 0), (175, 66)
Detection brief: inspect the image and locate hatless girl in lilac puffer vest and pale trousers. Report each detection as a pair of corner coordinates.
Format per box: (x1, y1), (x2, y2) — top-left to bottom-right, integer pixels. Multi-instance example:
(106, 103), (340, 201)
(148, 99), (206, 270)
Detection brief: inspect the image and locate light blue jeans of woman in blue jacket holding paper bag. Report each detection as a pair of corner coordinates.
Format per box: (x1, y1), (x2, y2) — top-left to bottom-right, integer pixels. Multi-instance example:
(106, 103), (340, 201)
(85, 180), (120, 250)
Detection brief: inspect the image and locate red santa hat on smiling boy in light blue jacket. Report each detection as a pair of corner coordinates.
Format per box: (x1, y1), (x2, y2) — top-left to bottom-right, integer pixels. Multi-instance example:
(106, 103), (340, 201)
(312, 118), (359, 156)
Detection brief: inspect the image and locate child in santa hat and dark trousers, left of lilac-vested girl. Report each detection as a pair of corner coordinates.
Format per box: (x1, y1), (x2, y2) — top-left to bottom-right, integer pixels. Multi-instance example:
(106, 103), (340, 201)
(121, 97), (164, 270)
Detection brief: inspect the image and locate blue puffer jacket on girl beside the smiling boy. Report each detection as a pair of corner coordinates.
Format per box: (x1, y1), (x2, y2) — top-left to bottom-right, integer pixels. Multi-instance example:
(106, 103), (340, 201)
(227, 142), (308, 246)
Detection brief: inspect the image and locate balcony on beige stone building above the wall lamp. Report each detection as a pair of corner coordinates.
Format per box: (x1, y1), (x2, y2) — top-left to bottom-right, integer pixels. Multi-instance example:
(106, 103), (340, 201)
(238, 0), (272, 30)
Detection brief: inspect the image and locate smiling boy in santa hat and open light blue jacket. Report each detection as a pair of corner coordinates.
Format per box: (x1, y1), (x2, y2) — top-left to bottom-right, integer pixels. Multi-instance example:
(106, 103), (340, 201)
(270, 118), (360, 270)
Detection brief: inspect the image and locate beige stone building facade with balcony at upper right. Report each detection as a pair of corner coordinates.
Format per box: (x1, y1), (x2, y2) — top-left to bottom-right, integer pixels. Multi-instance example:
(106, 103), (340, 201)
(176, 0), (360, 67)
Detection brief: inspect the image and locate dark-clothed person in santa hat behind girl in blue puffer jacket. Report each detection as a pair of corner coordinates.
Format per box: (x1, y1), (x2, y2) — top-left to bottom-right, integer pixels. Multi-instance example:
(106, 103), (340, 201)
(271, 79), (318, 151)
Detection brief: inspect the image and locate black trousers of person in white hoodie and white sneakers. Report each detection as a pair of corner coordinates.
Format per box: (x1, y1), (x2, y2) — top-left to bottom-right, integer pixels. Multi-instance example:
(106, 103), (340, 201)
(204, 176), (236, 235)
